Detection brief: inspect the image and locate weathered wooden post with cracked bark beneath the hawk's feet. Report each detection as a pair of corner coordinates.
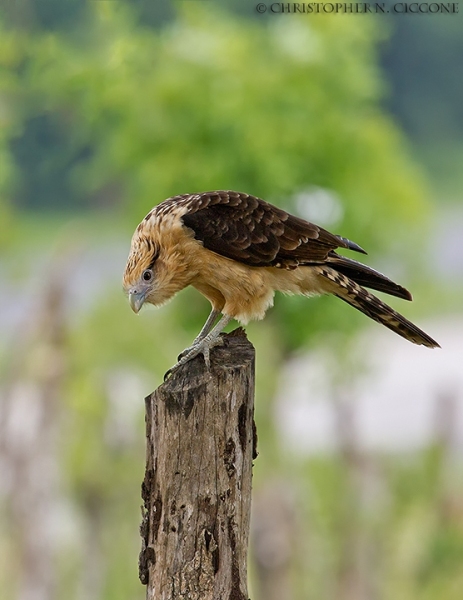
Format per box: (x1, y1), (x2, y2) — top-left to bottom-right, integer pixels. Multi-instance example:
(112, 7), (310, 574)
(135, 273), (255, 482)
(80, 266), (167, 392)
(139, 330), (256, 600)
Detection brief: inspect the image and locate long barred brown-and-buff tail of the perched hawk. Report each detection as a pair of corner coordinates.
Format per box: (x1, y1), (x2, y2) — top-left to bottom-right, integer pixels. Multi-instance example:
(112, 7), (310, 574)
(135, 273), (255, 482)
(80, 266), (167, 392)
(318, 265), (440, 348)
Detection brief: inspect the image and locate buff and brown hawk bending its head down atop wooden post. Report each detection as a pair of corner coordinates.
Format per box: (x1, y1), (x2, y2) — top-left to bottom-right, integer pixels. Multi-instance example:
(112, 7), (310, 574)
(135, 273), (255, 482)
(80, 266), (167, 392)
(123, 190), (440, 377)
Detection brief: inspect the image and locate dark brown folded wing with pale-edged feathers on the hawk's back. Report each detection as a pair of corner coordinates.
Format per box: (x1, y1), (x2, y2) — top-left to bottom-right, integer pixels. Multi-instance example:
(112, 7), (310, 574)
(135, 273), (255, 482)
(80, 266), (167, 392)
(178, 191), (365, 269)
